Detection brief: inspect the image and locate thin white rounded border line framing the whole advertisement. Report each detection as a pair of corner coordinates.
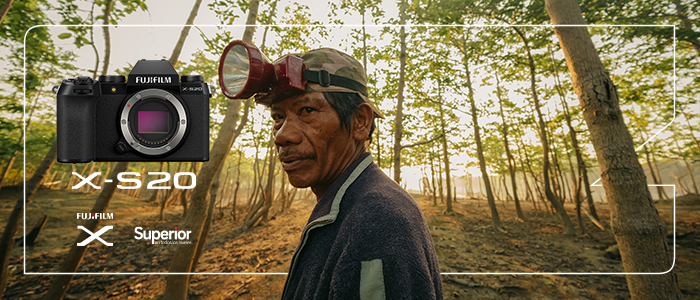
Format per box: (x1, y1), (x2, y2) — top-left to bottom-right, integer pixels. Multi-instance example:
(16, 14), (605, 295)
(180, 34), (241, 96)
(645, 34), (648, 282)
(22, 24), (676, 275)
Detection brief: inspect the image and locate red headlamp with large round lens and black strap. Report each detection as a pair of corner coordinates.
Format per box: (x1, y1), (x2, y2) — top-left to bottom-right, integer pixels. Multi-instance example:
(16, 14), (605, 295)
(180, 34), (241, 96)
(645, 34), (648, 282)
(219, 40), (367, 104)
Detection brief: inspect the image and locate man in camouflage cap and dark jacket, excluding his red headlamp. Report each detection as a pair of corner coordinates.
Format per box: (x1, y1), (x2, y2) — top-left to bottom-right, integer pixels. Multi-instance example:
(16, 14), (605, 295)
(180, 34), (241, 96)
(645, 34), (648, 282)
(266, 48), (442, 300)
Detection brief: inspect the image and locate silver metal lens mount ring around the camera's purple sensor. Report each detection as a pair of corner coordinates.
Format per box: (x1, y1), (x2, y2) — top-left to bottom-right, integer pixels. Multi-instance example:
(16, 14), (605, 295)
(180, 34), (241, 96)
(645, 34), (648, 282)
(119, 89), (188, 156)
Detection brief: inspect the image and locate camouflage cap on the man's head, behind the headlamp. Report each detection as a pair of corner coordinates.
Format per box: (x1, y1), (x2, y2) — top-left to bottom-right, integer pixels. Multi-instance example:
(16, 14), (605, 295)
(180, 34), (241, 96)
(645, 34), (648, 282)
(298, 48), (384, 119)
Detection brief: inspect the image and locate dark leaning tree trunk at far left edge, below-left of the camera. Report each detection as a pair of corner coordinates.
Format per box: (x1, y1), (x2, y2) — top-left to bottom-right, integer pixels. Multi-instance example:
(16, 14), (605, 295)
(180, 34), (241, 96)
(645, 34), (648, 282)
(0, 142), (56, 295)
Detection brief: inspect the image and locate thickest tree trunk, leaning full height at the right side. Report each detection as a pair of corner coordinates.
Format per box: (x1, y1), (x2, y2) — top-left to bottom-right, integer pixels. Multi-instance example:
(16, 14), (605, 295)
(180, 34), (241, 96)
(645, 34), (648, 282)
(545, 0), (683, 299)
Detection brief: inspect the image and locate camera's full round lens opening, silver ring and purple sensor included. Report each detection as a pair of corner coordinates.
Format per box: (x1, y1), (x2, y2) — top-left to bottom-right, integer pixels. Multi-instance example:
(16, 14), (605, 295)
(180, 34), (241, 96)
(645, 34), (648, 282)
(119, 89), (188, 156)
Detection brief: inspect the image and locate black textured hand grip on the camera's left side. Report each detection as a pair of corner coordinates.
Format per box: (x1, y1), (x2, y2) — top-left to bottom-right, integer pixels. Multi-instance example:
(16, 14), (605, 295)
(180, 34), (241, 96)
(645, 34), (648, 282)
(56, 91), (99, 163)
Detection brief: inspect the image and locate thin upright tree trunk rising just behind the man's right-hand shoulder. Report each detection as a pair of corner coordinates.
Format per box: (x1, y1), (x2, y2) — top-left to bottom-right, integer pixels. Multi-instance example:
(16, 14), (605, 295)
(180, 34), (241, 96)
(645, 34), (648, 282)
(393, 0), (407, 184)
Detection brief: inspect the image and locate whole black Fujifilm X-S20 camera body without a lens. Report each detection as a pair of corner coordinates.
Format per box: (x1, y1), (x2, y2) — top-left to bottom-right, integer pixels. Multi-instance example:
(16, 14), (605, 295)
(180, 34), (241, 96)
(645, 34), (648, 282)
(56, 59), (211, 163)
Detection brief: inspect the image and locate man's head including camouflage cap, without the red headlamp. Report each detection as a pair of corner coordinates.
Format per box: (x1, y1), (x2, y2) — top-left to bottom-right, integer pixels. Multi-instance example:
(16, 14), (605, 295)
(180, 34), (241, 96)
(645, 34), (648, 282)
(270, 48), (383, 197)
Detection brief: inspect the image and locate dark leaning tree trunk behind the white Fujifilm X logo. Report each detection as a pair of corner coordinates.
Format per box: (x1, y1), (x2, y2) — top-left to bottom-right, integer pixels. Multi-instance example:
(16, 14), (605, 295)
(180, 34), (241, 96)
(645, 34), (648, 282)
(44, 161), (129, 300)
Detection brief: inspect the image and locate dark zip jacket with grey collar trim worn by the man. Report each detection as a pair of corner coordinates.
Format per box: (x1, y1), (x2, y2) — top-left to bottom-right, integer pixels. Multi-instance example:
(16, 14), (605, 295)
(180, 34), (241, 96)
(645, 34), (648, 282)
(282, 153), (442, 300)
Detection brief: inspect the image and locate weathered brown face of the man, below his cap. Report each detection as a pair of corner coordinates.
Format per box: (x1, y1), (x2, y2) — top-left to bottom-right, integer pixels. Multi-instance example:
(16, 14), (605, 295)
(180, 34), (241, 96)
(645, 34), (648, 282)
(270, 92), (357, 191)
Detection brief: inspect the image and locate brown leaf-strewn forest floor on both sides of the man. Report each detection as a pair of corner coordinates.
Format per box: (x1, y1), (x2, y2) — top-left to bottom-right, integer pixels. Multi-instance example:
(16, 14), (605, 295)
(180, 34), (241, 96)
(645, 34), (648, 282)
(0, 187), (700, 299)
